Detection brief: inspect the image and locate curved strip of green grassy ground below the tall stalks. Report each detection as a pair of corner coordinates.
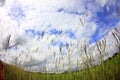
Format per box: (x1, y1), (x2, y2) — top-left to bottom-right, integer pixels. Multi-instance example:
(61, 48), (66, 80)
(3, 53), (120, 80)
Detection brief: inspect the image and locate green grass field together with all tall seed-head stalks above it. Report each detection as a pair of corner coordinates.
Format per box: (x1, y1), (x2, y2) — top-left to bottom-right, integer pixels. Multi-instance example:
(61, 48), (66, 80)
(2, 21), (120, 80)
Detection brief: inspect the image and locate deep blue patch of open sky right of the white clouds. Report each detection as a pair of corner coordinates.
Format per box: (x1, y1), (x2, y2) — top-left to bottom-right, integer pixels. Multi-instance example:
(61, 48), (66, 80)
(90, 1), (120, 43)
